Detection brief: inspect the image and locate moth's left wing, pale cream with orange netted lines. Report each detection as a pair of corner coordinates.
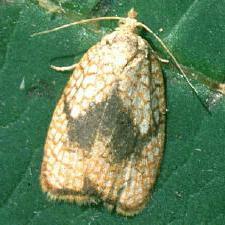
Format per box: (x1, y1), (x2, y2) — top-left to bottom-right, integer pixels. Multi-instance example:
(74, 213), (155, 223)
(40, 41), (118, 203)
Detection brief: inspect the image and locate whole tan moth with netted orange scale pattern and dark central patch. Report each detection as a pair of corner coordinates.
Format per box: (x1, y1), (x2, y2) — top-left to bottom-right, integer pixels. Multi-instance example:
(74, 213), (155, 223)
(37, 9), (192, 216)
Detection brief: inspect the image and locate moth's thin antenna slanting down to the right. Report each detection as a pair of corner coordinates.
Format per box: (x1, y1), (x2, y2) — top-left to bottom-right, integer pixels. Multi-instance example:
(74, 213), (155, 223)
(137, 22), (199, 96)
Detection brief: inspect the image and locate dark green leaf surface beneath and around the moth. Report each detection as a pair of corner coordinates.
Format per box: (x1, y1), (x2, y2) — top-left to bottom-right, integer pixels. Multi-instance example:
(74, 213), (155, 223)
(0, 0), (225, 225)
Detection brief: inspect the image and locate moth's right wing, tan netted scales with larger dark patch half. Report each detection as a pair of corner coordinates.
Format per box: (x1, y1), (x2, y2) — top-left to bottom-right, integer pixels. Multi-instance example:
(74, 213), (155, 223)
(82, 51), (165, 216)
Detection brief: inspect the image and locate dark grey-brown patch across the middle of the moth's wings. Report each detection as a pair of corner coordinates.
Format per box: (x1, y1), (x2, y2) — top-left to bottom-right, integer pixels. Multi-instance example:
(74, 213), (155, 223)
(64, 94), (154, 161)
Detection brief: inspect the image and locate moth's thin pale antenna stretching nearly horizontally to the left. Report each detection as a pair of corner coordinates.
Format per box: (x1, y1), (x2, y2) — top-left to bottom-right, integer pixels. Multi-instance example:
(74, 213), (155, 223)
(31, 16), (125, 37)
